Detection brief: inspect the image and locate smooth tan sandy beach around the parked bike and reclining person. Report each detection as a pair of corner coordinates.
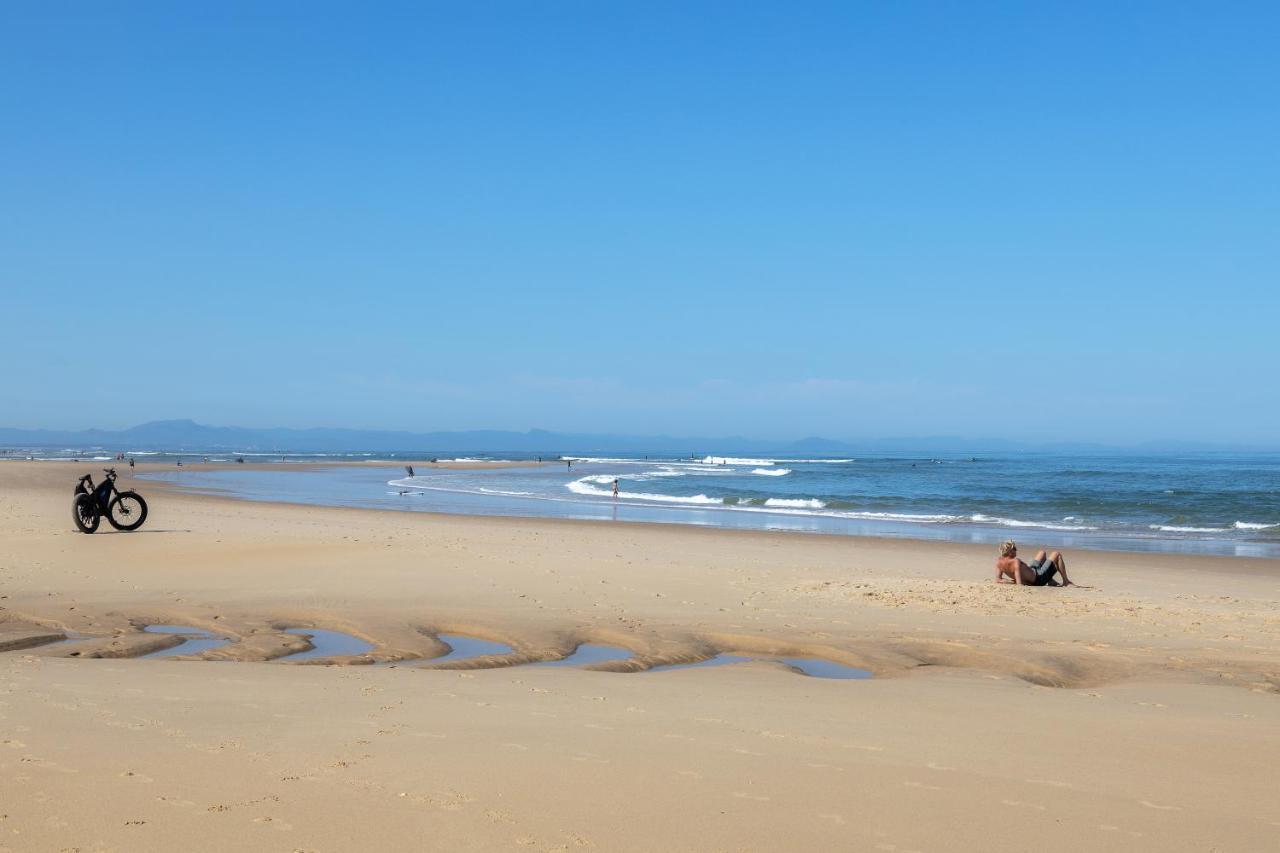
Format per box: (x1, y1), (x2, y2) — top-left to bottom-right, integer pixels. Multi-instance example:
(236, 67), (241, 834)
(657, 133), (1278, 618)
(0, 461), (1280, 853)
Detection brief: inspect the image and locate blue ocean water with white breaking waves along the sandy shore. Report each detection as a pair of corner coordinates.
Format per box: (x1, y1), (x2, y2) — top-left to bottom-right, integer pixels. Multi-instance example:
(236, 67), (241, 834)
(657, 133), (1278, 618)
(140, 453), (1280, 557)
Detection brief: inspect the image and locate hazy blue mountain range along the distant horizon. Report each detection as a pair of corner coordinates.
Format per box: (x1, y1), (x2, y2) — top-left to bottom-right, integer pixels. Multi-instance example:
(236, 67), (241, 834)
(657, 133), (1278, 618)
(0, 420), (1261, 456)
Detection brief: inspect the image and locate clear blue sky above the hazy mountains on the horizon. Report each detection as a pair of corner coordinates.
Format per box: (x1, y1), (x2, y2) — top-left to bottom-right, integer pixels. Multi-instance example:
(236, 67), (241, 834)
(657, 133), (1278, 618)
(0, 0), (1280, 444)
